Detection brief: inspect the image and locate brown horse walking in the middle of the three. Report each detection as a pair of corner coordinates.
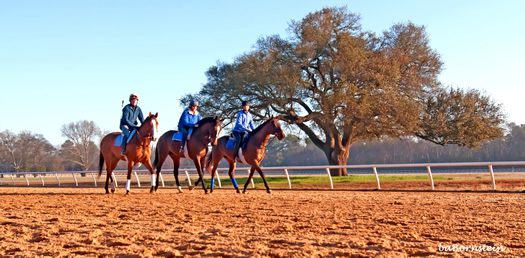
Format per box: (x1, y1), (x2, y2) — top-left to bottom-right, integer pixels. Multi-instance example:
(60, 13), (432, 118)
(153, 117), (222, 193)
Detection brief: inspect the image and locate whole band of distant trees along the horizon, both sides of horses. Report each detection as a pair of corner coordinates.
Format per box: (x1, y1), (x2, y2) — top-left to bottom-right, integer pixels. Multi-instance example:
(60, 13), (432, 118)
(0, 124), (525, 172)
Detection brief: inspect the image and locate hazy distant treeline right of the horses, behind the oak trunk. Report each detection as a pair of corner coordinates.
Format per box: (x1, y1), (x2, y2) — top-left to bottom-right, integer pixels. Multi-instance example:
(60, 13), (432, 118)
(263, 124), (525, 166)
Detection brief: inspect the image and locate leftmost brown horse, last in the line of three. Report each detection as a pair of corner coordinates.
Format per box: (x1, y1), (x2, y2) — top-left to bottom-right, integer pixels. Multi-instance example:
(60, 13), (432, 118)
(98, 113), (159, 194)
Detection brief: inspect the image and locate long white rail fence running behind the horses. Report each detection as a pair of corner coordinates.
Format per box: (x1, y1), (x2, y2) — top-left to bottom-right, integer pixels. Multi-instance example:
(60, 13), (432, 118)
(0, 161), (525, 190)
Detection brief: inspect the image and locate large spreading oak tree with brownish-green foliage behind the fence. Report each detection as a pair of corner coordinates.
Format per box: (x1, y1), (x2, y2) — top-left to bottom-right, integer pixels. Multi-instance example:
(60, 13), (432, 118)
(186, 8), (504, 175)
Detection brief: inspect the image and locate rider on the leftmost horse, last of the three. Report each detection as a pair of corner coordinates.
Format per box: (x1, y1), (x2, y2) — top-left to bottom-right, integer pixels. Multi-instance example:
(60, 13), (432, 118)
(120, 94), (144, 155)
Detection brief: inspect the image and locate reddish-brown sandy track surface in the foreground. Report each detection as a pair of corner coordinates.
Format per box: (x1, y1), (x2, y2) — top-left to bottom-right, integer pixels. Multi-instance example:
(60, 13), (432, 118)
(0, 187), (525, 257)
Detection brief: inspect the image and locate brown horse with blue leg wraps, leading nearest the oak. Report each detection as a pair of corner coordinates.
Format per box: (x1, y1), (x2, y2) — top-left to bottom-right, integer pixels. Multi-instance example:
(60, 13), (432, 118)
(206, 117), (285, 193)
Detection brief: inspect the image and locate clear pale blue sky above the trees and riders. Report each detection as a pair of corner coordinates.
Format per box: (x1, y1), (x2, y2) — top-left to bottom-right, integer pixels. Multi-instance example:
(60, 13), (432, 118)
(0, 0), (525, 145)
